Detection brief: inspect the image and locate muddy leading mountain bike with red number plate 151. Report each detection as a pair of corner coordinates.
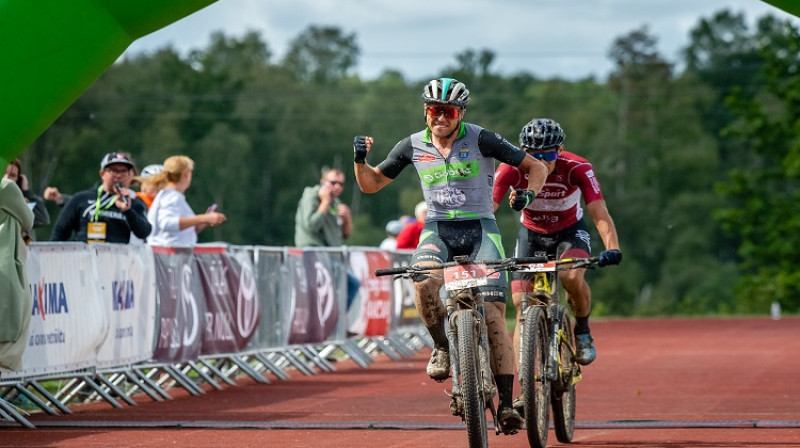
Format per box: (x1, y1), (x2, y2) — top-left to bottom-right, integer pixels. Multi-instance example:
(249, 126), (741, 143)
(375, 256), (539, 448)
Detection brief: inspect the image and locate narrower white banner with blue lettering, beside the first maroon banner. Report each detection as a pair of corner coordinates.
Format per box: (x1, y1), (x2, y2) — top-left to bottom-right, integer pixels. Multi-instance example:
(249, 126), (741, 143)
(90, 244), (157, 367)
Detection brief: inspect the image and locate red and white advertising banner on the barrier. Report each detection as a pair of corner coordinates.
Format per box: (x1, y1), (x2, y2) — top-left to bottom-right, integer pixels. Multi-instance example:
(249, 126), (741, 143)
(349, 248), (392, 336)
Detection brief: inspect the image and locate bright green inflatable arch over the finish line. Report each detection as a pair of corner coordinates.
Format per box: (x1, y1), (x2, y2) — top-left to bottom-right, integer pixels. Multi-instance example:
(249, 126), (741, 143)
(0, 0), (800, 168)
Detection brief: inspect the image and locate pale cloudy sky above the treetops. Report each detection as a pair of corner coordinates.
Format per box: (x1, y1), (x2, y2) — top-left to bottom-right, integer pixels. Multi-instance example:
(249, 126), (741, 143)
(123, 0), (800, 80)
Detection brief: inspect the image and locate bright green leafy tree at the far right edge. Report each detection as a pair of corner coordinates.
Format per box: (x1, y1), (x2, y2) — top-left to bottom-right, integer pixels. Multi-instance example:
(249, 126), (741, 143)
(718, 17), (800, 312)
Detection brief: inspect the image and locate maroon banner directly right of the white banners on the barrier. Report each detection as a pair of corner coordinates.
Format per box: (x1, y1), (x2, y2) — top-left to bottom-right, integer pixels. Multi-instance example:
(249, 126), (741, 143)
(152, 246), (206, 362)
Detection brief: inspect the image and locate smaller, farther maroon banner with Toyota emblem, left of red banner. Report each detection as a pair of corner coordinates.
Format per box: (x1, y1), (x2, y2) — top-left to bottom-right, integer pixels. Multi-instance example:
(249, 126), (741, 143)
(287, 249), (345, 344)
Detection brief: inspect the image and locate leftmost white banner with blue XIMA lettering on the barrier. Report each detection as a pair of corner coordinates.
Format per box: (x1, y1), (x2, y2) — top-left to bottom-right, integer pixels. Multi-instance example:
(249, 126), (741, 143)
(11, 243), (108, 378)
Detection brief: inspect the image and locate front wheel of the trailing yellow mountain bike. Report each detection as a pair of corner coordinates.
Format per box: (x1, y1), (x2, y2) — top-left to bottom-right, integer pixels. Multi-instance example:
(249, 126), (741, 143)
(520, 306), (550, 448)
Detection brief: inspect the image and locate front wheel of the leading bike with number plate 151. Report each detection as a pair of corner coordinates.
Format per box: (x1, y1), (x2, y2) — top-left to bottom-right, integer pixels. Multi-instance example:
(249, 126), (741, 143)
(456, 310), (489, 448)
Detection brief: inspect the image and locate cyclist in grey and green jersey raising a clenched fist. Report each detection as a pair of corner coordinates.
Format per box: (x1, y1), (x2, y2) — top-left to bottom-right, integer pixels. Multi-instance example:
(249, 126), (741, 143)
(353, 78), (547, 434)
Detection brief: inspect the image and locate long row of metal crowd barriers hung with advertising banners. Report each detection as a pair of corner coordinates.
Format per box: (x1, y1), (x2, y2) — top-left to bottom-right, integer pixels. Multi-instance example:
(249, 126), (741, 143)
(0, 243), (432, 427)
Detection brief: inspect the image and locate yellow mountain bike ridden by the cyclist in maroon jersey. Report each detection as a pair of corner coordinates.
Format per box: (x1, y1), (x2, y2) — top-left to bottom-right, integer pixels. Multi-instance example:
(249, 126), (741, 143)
(513, 257), (599, 448)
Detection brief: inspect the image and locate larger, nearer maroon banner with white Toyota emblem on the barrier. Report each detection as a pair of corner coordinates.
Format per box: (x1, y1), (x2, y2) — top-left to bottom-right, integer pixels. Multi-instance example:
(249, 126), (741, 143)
(194, 245), (258, 355)
